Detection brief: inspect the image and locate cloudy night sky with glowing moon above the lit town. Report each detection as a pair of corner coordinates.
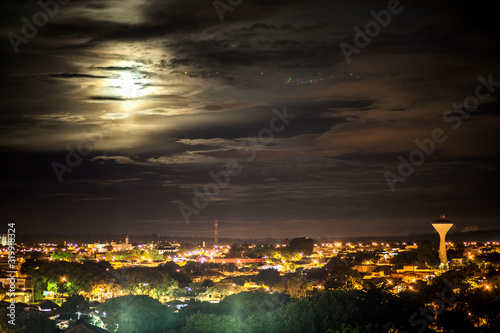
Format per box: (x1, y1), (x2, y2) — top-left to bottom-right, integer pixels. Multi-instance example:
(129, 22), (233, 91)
(0, 0), (500, 238)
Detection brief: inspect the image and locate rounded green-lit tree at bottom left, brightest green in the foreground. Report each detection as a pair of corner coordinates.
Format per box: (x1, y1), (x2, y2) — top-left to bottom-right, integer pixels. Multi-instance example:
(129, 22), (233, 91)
(97, 295), (176, 333)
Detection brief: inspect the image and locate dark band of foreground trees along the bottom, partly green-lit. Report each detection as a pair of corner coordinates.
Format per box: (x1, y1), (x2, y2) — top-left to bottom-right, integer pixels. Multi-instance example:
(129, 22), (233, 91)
(1, 269), (500, 333)
